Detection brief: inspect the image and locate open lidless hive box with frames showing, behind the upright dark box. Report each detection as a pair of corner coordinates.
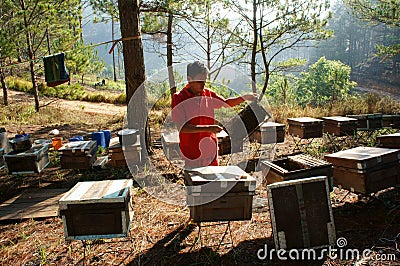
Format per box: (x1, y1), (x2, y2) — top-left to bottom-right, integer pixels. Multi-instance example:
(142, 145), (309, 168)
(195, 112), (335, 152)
(260, 154), (333, 190)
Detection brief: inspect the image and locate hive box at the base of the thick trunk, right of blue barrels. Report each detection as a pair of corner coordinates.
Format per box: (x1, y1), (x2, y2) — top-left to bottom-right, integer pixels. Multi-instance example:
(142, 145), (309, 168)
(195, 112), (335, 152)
(108, 137), (142, 167)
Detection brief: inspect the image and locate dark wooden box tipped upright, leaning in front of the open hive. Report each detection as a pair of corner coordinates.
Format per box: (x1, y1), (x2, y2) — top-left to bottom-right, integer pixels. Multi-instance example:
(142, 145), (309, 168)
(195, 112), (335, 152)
(267, 177), (336, 250)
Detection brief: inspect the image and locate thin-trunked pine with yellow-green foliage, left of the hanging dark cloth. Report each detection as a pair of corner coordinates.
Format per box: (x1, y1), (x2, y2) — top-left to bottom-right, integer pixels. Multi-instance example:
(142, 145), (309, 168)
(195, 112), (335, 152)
(4, 0), (81, 111)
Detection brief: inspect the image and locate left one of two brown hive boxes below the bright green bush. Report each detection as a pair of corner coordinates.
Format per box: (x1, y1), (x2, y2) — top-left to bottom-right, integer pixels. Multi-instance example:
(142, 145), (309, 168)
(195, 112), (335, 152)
(287, 117), (324, 139)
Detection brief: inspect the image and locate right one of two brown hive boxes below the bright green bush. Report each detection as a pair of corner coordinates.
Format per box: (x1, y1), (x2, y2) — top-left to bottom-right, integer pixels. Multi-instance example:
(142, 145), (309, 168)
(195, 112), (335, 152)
(322, 116), (357, 137)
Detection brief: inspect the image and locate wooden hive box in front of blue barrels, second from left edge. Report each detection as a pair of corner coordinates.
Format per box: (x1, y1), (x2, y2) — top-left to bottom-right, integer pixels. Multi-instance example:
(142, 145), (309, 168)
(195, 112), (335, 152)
(58, 141), (97, 169)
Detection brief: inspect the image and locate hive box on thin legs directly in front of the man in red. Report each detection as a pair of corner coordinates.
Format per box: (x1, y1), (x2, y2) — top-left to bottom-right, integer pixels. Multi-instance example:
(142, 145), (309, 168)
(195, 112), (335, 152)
(185, 166), (256, 222)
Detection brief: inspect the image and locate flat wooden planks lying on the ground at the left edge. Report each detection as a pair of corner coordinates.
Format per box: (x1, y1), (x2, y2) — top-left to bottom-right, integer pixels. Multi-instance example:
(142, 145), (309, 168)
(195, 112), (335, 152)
(0, 188), (68, 221)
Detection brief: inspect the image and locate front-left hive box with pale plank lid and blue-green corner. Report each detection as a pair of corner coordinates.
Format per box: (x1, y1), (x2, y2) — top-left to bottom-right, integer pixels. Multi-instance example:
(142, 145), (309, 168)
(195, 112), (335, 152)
(59, 179), (133, 240)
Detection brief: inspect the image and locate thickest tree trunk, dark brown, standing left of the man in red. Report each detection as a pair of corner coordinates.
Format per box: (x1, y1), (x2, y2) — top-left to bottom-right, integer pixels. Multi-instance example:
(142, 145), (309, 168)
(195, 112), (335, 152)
(118, 0), (150, 160)
